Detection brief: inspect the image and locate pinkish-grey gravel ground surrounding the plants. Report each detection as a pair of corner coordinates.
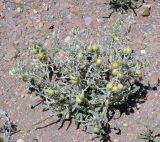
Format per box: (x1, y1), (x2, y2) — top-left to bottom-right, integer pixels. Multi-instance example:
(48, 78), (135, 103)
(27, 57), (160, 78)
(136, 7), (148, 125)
(0, 0), (160, 142)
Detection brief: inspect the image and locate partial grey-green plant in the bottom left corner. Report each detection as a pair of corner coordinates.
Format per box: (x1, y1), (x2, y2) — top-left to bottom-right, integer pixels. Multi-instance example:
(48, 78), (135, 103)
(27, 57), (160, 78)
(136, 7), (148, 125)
(0, 109), (16, 142)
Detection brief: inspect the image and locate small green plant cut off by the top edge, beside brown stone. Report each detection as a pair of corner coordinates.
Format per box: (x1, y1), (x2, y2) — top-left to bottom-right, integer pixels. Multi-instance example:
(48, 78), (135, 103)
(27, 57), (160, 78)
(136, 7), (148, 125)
(104, 0), (144, 18)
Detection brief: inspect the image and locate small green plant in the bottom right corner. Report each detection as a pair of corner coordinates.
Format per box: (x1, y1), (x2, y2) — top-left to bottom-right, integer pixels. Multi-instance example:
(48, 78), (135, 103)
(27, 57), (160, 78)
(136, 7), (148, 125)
(138, 124), (160, 142)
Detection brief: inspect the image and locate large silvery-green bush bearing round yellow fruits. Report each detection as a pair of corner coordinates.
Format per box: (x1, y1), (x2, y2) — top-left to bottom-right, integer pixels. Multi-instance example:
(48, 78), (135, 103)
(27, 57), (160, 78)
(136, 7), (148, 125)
(12, 18), (143, 140)
